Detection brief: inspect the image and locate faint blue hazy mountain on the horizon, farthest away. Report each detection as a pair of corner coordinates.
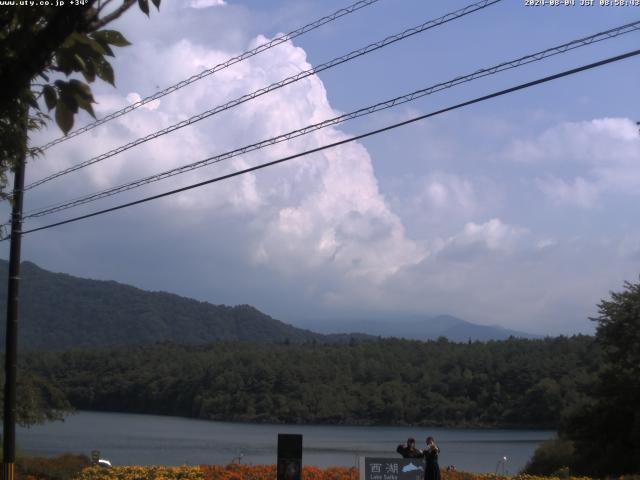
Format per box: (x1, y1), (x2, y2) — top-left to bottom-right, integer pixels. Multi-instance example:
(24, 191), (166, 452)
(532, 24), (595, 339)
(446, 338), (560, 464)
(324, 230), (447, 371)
(304, 315), (542, 342)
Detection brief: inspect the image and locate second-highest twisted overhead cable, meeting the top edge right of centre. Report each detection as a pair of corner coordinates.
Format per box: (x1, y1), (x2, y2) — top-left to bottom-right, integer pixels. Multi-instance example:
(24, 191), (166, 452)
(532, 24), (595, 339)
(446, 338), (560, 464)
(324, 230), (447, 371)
(24, 0), (502, 190)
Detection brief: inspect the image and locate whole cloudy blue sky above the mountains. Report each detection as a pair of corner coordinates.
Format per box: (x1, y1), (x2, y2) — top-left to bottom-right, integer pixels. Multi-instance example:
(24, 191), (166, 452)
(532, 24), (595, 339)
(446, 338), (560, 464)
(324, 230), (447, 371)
(0, 0), (640, 335)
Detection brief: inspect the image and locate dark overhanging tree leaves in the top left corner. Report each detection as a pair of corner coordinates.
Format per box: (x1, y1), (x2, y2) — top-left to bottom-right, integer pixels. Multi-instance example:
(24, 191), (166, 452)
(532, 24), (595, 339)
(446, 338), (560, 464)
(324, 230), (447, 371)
(0, 0), (160, 200)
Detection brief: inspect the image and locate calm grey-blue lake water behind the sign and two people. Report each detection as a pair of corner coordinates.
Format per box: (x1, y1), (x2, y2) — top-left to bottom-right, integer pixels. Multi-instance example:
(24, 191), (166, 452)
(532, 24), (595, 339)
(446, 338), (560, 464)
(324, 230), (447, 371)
(16, 412), (554, 473)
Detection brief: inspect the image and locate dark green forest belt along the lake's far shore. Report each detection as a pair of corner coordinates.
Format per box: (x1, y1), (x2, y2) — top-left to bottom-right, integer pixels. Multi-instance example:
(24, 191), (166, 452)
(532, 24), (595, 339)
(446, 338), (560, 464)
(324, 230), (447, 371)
(23, 336), (600, 428)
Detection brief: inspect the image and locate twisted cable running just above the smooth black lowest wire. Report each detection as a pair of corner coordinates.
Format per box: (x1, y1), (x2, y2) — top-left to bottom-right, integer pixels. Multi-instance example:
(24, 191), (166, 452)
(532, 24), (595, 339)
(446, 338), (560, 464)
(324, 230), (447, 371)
(18, 21), (640, 219)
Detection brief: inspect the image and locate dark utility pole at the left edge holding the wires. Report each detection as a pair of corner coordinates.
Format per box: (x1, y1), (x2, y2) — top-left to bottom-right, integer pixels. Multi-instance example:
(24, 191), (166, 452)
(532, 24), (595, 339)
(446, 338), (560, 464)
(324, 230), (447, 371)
(0, 146), (26, 480)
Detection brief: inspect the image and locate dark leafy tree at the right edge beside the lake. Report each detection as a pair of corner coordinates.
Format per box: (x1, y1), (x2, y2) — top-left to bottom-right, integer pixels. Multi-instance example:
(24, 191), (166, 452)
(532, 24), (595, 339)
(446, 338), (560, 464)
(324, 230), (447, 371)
(561, 282), (640, 476)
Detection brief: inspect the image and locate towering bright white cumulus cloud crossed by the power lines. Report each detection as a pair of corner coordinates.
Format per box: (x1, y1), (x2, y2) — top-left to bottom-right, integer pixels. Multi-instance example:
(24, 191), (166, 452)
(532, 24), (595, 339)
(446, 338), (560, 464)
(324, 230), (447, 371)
(25, 37), (424, 298)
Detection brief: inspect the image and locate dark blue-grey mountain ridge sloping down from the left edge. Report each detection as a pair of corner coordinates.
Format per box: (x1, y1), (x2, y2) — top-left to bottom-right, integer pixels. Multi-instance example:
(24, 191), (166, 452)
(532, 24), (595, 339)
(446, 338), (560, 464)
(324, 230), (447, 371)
(0, 260), (365, 350)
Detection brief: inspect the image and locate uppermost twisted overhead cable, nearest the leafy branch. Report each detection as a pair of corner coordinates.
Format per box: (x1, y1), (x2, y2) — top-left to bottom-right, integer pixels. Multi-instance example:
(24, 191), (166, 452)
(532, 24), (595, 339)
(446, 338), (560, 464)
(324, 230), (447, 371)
(38, 0), (379, 151)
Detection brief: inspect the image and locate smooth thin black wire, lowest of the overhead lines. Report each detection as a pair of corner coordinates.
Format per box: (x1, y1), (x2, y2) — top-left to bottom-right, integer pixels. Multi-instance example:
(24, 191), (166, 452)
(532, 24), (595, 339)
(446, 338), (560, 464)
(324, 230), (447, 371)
(8, 49), (640, 241)
